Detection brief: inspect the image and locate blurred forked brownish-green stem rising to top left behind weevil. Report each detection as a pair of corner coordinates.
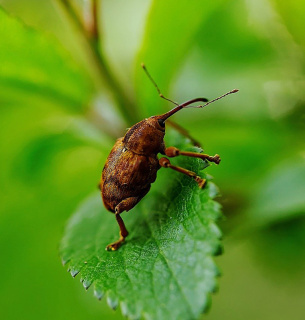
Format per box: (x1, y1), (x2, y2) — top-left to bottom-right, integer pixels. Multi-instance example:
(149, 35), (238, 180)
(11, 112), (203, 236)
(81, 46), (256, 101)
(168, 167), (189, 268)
(59, 0), (138, 124)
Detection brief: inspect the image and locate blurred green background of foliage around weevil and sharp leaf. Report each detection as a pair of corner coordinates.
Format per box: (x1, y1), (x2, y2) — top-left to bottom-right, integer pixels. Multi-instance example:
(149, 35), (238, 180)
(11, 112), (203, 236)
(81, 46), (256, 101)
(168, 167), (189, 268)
(0, 0), (305, 320)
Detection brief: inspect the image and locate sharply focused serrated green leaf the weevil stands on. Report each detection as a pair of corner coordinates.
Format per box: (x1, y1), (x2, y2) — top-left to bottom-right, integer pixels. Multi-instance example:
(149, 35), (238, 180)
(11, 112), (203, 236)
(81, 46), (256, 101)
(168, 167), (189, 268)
(60, 136), (222, 320)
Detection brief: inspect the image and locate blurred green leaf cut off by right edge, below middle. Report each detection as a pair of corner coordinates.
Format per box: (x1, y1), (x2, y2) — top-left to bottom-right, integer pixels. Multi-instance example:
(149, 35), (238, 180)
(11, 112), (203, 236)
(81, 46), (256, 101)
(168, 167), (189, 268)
(242, 160), (305, 281)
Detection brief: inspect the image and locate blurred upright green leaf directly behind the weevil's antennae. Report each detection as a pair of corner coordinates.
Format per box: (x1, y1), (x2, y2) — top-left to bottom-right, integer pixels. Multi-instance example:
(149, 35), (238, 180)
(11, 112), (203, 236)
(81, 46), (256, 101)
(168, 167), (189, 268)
(136, 0), (223, 117)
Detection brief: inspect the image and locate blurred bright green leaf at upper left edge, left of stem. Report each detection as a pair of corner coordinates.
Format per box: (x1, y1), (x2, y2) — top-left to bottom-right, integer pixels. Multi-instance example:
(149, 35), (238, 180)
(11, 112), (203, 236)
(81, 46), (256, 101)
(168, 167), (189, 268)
(0, 8), (92, 111)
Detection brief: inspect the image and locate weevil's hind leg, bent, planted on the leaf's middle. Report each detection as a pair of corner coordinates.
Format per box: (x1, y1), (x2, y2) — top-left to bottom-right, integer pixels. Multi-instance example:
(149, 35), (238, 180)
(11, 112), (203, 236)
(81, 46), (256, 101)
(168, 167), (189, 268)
(106, 197), (139, 251)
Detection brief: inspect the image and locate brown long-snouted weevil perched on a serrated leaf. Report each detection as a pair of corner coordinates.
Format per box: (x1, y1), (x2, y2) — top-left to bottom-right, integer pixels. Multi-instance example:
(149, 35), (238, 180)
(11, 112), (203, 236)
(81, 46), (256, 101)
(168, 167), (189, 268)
(99, 65), (238, 251)
